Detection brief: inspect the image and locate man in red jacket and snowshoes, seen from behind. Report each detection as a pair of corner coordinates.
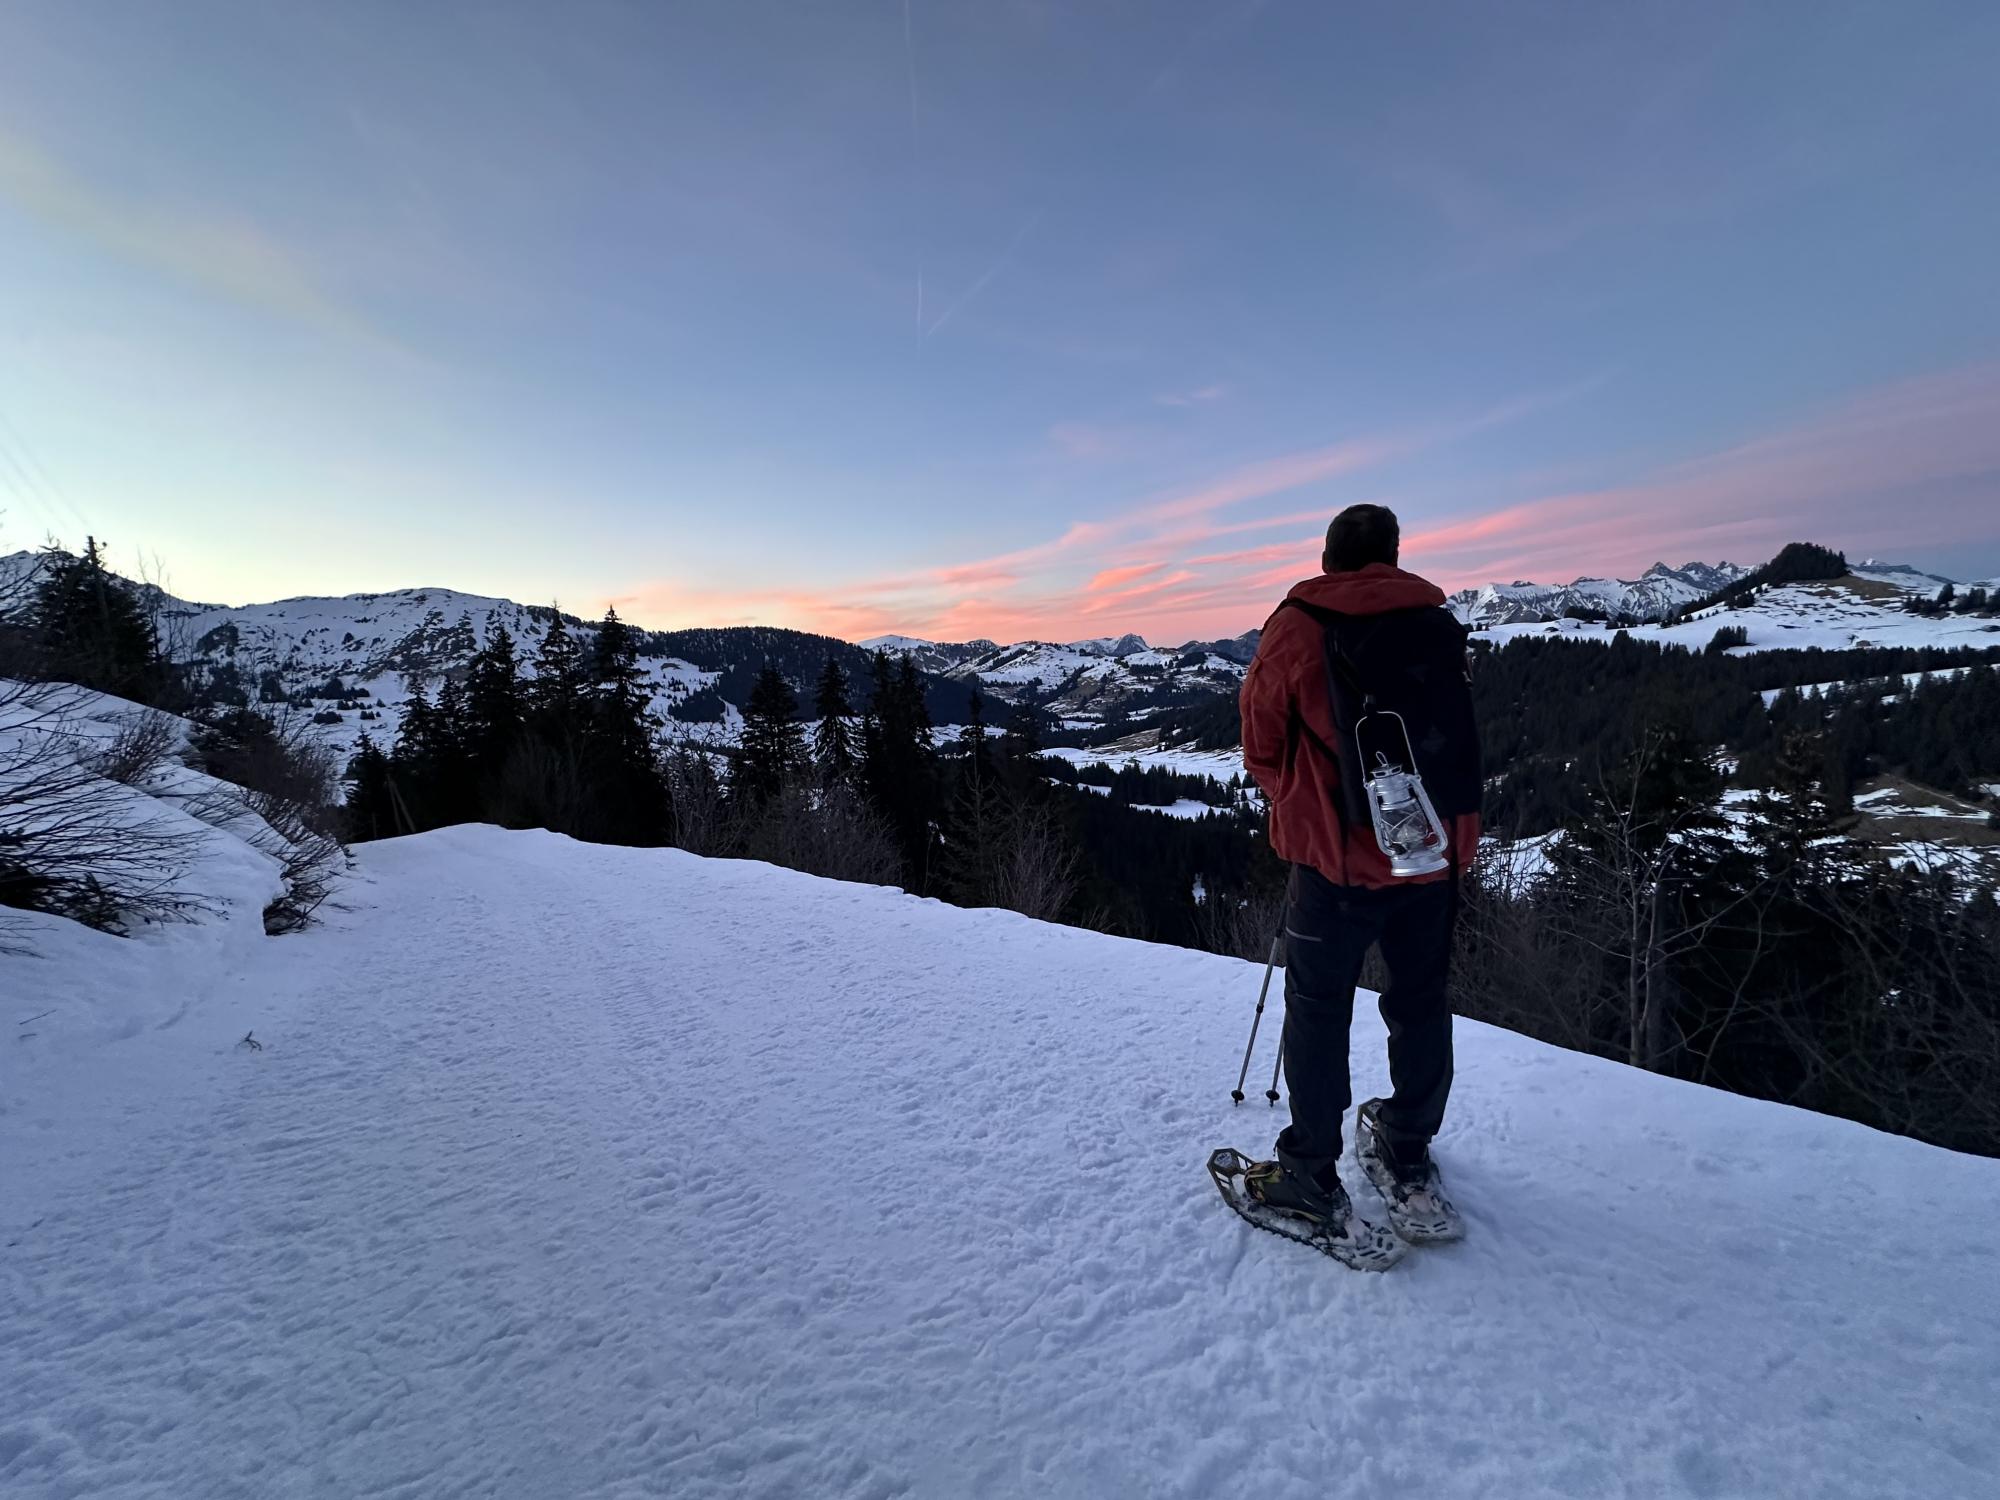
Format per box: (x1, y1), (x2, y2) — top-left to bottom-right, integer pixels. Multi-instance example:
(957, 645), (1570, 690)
(1242, 506), (1480, 1240)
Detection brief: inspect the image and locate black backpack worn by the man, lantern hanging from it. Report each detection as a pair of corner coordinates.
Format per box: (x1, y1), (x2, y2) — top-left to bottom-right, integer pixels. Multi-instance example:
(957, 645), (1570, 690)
(1280, 598), (1482, 828)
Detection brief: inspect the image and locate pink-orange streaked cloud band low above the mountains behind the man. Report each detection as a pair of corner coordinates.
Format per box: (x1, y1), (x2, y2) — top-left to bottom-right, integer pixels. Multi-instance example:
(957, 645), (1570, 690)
(616, 366), (2000, 644)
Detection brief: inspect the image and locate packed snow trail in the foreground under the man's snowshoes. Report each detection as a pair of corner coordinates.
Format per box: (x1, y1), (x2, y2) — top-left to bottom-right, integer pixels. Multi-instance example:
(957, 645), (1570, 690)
(0, 828), (2000, 1500)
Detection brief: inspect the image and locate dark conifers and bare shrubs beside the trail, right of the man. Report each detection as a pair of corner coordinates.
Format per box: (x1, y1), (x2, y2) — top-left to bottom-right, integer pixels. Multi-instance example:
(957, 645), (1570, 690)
(1454, 728), (2000, 1154)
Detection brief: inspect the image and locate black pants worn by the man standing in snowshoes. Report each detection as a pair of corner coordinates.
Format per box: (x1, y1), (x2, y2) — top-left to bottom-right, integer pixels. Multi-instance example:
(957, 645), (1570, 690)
(1278, 866), (1458, 1184)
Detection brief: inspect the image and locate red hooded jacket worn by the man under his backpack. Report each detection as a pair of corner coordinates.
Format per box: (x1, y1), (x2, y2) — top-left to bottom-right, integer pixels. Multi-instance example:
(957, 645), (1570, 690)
(1240, 562), (1480, 888)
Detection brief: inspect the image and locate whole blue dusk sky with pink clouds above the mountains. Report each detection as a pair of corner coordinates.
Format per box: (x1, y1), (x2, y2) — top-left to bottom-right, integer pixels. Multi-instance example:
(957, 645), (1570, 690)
(0, 0), (2000, 642)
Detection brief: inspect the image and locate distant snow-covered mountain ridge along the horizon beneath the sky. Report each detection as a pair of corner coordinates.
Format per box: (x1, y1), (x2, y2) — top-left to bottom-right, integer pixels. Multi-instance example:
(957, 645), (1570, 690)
(0, 552), (1946, 764)
